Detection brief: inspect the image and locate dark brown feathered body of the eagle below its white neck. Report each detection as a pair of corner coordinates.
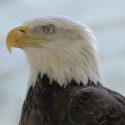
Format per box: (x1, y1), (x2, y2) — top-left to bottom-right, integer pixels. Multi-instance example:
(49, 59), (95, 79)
(19, 75), (125, 125)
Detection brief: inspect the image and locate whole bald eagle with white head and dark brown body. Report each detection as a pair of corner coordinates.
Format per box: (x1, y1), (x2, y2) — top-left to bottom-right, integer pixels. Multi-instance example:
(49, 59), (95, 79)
(6, 16), (125, 125)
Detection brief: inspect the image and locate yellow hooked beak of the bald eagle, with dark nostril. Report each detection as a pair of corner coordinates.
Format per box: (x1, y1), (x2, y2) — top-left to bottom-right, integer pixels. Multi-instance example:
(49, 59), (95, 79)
(6, 26), (30, 53)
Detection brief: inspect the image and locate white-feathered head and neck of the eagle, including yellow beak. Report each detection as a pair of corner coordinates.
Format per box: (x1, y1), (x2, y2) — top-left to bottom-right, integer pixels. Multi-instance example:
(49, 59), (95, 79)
(6, 16), (100, 86)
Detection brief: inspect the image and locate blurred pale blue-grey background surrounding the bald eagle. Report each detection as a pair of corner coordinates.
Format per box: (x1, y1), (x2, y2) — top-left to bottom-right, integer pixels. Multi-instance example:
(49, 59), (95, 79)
(0, 0), (125, 125)
